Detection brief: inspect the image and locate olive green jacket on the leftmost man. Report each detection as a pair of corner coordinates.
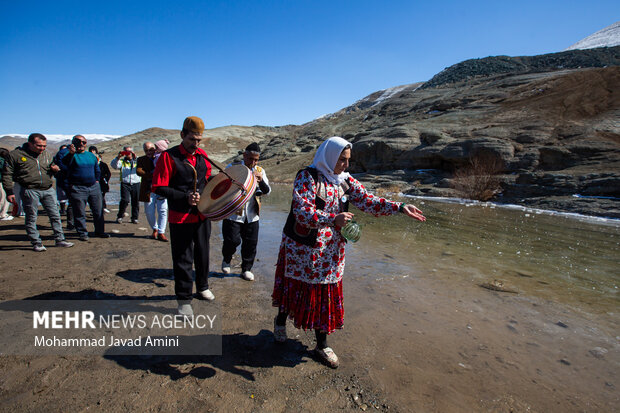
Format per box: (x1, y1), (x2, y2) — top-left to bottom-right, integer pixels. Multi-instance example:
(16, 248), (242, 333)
(2, 143), (54, 195)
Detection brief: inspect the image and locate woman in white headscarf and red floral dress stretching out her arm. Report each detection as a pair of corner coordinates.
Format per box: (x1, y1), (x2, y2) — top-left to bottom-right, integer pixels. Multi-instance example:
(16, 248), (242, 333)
(272, 136), (426, 368)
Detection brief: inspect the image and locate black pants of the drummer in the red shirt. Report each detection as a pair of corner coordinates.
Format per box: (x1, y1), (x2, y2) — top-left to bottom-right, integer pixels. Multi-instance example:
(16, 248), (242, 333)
(170, 220), (211, 300)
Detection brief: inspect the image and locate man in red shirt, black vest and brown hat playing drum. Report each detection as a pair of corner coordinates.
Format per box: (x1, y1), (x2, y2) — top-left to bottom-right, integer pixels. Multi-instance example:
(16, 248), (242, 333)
(151, 116), (215, 316)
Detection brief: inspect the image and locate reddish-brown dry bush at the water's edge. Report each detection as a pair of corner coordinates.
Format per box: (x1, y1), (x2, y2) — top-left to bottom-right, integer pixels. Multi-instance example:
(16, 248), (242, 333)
(452, 155), (504, 201)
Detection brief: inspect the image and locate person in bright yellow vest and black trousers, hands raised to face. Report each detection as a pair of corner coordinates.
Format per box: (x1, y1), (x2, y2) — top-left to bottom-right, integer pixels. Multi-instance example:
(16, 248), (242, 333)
(110, 146), (140, 224)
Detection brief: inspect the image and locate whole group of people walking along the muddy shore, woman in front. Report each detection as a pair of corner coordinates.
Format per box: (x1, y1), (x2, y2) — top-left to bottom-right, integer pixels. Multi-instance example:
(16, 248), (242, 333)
(2, 116), (426, 368)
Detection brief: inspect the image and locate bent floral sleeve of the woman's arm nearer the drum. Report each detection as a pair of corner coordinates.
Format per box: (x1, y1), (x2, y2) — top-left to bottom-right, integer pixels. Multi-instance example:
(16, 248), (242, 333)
(293, 170), (336, 228)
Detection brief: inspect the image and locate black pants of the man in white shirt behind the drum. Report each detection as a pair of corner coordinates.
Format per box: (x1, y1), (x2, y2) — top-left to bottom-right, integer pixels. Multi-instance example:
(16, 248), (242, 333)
(222, 219), (259, 272)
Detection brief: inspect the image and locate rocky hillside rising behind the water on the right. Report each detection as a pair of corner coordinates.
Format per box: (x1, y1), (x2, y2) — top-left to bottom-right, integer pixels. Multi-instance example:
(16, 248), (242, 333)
(254, 47), (620, 217)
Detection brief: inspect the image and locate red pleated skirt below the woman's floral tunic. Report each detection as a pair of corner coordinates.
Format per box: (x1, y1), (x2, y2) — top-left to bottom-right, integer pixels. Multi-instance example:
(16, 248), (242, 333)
(271, 245), (344, 334)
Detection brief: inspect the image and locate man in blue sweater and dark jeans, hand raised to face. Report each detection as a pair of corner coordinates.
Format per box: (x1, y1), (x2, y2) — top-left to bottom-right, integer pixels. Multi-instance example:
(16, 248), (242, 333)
(62, 135), (110, 241)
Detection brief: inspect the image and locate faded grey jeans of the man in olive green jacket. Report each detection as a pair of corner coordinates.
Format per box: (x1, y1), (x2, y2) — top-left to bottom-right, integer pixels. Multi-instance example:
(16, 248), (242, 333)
(20, 187), (65, 245)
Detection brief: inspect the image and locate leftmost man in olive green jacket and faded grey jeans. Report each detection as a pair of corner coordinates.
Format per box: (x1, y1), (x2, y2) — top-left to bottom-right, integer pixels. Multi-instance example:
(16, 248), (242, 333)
(2, 133), (73, 252)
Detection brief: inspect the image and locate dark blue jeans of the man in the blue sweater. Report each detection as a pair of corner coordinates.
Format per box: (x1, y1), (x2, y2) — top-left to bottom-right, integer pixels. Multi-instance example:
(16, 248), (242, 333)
(69, 182), (104, 236)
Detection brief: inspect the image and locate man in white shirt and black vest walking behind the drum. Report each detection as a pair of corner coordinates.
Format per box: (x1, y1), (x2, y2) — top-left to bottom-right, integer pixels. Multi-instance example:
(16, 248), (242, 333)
(222, 143), (271, 281)
